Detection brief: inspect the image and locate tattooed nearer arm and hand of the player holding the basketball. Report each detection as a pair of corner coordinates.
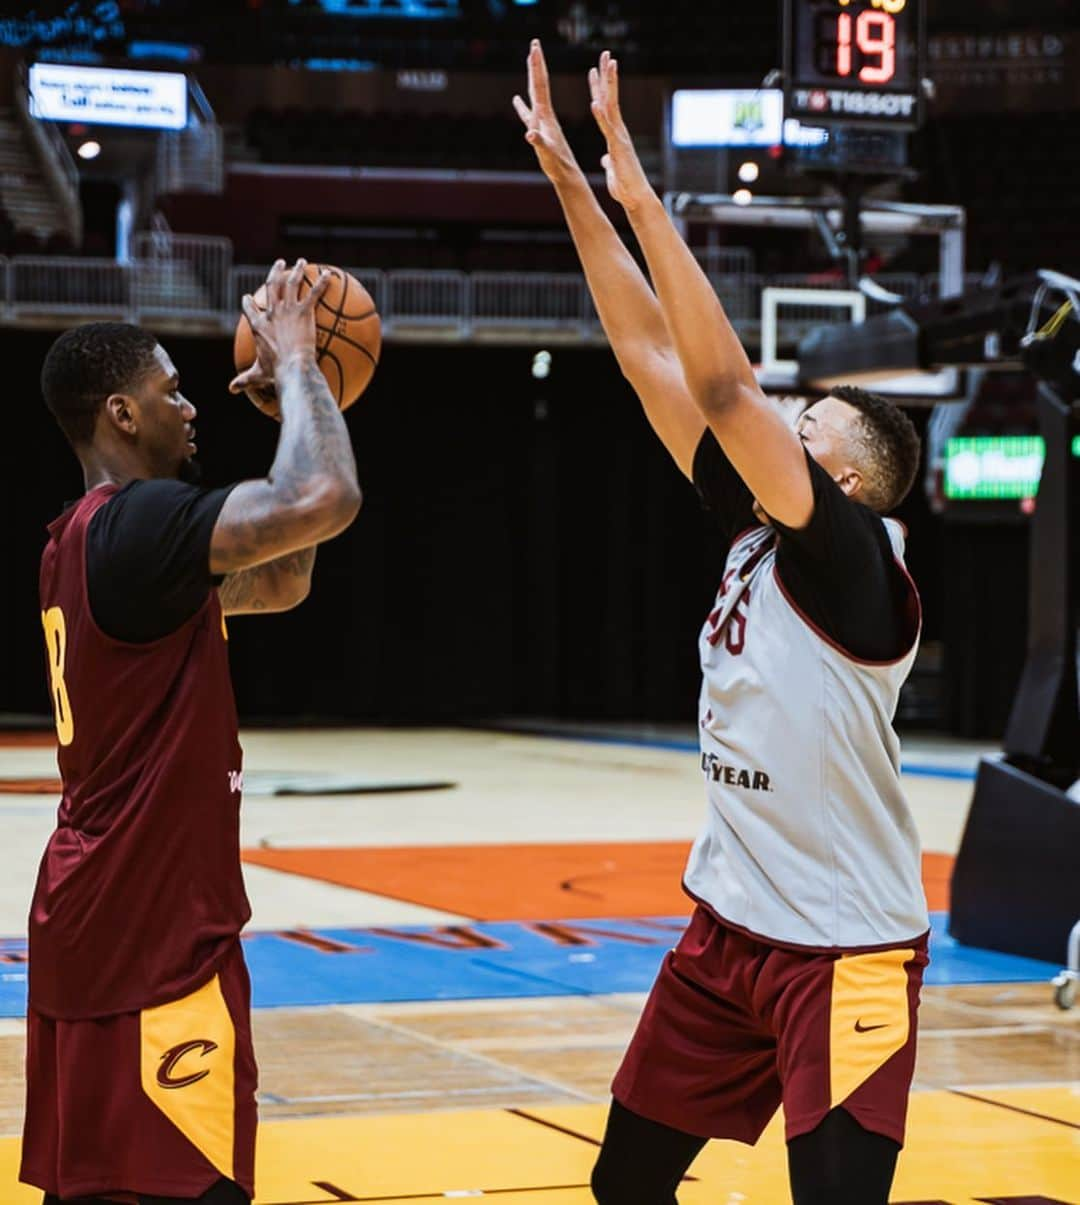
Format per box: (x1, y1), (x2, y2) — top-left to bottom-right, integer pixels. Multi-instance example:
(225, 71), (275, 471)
(210, 259), (360, 574)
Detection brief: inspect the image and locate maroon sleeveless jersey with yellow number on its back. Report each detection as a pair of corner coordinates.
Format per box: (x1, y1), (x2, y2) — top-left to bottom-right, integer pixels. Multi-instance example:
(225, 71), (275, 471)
(29, 486), (251, 1021)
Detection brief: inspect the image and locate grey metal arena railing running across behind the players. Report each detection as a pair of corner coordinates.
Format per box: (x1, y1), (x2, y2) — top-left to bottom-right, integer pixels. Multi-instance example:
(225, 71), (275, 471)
(0, 255), (981, 346)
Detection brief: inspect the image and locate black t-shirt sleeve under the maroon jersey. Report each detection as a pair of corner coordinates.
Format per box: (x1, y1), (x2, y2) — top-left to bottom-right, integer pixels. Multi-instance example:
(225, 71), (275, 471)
(87, 478), (231, 643)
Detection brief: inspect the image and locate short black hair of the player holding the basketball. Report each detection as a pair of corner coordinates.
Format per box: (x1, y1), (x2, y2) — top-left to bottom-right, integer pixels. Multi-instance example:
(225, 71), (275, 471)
(41, 322), (158, 447)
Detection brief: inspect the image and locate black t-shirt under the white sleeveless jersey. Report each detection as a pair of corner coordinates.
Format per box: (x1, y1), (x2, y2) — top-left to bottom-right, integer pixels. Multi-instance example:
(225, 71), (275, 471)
(693, 430), (918, 662)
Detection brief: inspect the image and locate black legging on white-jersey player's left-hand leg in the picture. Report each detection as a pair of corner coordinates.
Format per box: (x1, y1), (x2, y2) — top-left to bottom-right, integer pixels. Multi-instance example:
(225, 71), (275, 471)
(592, 1100), (708, 1205)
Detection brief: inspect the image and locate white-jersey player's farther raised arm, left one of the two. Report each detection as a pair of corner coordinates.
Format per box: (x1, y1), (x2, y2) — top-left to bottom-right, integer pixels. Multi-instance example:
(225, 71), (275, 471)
(513, 41), (705, 476)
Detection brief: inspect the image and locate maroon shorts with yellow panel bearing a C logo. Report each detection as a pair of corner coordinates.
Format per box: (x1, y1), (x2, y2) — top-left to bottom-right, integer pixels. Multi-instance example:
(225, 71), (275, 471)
(19, 941), (256, 1199)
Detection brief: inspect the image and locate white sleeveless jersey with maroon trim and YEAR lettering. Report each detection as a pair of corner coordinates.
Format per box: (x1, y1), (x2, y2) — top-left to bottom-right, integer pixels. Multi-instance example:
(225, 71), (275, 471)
(685, 519), (929, 948)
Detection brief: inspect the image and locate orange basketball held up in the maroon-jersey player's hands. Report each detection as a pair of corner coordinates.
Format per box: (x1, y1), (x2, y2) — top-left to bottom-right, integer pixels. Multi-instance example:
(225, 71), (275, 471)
(233, 264), (382, 410)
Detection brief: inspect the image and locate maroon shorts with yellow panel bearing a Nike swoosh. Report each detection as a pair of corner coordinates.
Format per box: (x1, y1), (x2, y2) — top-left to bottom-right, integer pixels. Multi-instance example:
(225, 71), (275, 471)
(612, 907), (927, 1144)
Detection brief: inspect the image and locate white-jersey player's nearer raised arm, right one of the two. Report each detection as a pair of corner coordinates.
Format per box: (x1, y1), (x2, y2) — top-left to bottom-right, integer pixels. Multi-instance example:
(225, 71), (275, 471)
(589, 51), (814, 528)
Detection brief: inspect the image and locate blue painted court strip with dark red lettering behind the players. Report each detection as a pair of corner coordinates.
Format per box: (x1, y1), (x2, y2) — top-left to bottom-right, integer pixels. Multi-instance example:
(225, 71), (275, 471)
(0, 913), (1061, 1017)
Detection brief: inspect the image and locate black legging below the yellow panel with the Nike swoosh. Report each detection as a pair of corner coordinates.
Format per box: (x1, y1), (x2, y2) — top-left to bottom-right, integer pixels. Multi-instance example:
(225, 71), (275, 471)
(787, 1107), (900, 1205)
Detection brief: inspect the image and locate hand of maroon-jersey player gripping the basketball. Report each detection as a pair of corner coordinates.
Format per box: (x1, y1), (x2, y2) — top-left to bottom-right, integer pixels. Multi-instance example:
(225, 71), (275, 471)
(229, 259), (330, 418)
